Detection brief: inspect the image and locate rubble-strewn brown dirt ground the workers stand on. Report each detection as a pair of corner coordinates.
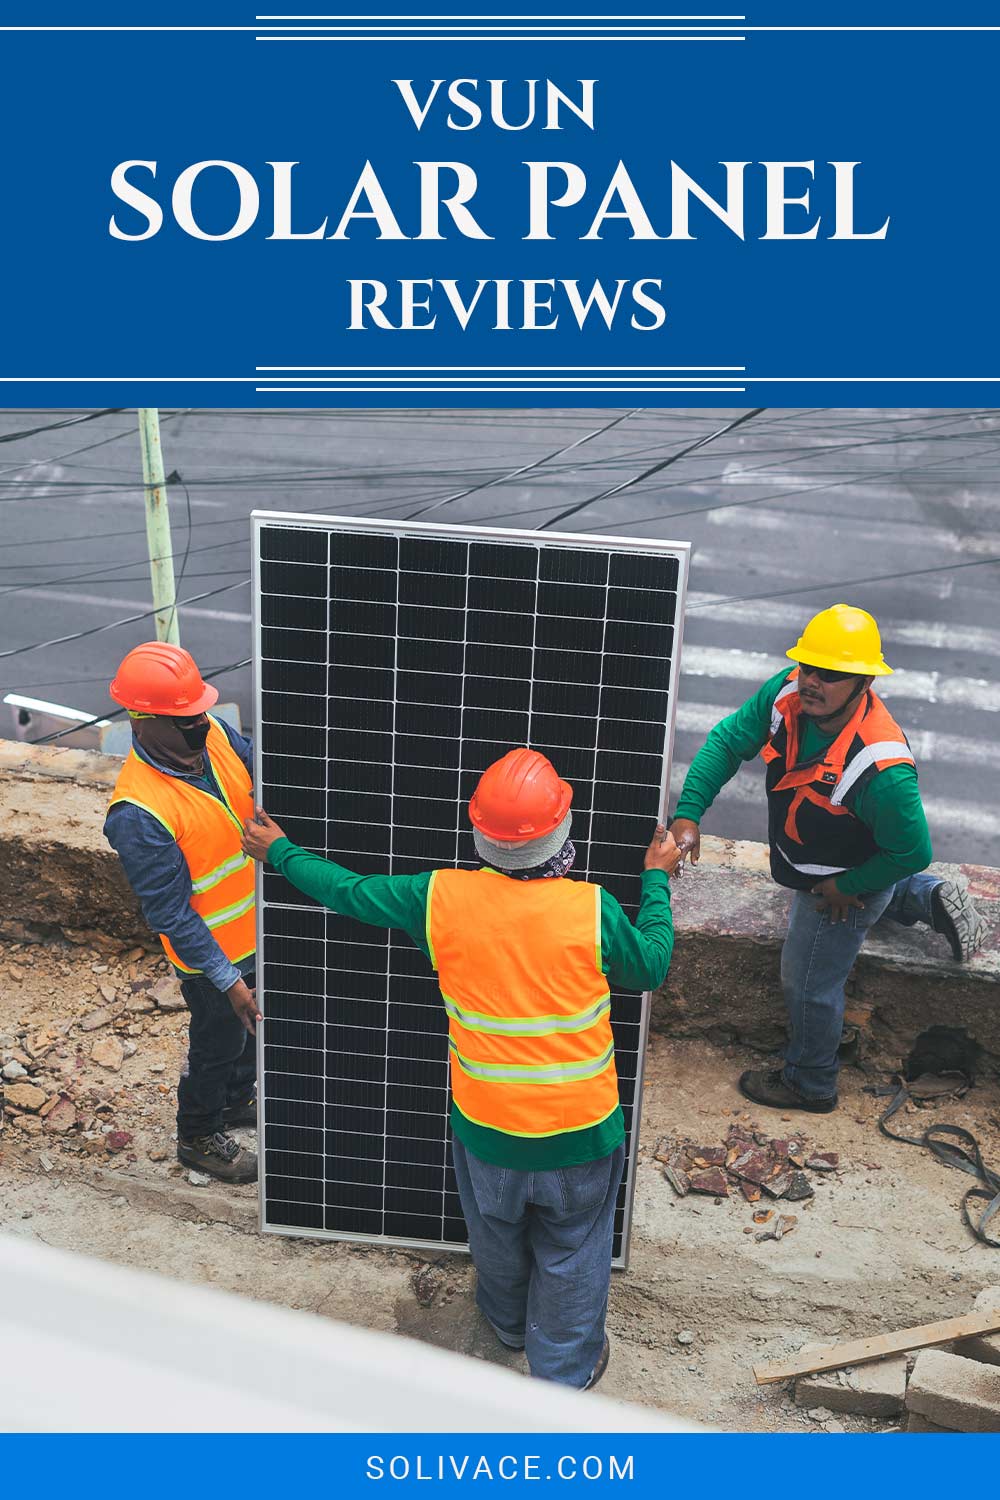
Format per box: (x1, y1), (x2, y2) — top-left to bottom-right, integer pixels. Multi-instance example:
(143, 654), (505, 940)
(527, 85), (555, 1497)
(0, 936), (1000, 1433)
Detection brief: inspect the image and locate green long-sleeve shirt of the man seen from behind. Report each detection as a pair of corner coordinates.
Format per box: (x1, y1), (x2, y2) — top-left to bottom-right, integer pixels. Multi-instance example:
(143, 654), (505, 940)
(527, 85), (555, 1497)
(268, 839), (673, 1172)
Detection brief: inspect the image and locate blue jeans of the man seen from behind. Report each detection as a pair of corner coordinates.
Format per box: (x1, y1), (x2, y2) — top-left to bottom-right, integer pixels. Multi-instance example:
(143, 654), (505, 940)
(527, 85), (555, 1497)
(451, 1137), (625, 1388)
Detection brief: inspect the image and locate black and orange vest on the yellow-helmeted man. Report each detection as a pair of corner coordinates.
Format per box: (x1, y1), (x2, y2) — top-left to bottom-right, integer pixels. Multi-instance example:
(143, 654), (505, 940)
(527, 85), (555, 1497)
(760, 668), (913, 891)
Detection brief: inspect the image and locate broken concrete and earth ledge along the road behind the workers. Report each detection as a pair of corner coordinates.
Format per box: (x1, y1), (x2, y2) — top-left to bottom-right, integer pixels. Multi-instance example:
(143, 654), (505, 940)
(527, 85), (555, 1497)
(0, 741), (1000, 1067)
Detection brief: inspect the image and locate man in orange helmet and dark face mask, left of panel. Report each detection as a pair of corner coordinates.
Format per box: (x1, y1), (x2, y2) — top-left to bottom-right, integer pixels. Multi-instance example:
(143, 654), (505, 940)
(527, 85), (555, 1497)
(103, 641), (261, 1184)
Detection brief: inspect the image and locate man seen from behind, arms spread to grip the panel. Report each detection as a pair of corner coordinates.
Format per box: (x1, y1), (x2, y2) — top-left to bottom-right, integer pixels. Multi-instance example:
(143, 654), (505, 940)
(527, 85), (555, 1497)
(243, 747), (681, 1389)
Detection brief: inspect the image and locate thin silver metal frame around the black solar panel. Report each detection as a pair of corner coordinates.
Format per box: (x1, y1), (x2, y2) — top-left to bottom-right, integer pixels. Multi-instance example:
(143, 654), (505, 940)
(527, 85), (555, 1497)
(250, 510), (691, 1271)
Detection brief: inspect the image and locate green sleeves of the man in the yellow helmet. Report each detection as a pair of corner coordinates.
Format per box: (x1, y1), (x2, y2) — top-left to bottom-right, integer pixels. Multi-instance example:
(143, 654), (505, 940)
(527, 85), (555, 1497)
(675, 668), (933, 896)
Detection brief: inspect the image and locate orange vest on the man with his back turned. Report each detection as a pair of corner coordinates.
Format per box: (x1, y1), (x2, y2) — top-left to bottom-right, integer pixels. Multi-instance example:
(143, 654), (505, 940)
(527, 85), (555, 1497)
(427, 870), (618, 1136)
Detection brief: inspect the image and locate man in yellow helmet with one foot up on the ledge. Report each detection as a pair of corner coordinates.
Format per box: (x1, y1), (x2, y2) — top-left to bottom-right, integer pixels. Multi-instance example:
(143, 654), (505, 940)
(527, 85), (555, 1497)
(670, 605), (982, 1113)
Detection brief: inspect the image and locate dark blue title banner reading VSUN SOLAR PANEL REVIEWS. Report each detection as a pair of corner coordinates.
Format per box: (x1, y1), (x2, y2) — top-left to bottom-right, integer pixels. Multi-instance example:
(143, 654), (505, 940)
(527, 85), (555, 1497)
(0, 0), (1000, 407)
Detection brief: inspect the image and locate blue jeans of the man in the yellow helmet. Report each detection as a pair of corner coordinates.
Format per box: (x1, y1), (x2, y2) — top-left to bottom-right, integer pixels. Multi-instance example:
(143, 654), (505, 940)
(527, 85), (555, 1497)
(781, 875), (940, 1100)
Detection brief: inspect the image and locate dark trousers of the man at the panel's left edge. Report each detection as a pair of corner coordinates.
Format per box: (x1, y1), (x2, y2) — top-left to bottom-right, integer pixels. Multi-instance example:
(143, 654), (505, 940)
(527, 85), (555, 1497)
(177, 974), (256, 1140)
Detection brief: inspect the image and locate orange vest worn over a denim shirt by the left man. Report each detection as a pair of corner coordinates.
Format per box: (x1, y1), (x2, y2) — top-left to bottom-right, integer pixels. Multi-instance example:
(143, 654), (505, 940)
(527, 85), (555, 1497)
(108, 716), (256, 974)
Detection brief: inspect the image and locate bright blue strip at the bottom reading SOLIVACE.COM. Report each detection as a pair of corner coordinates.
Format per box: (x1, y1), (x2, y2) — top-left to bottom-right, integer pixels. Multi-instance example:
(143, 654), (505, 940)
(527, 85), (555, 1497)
(0, 1433), (999, 1500)
